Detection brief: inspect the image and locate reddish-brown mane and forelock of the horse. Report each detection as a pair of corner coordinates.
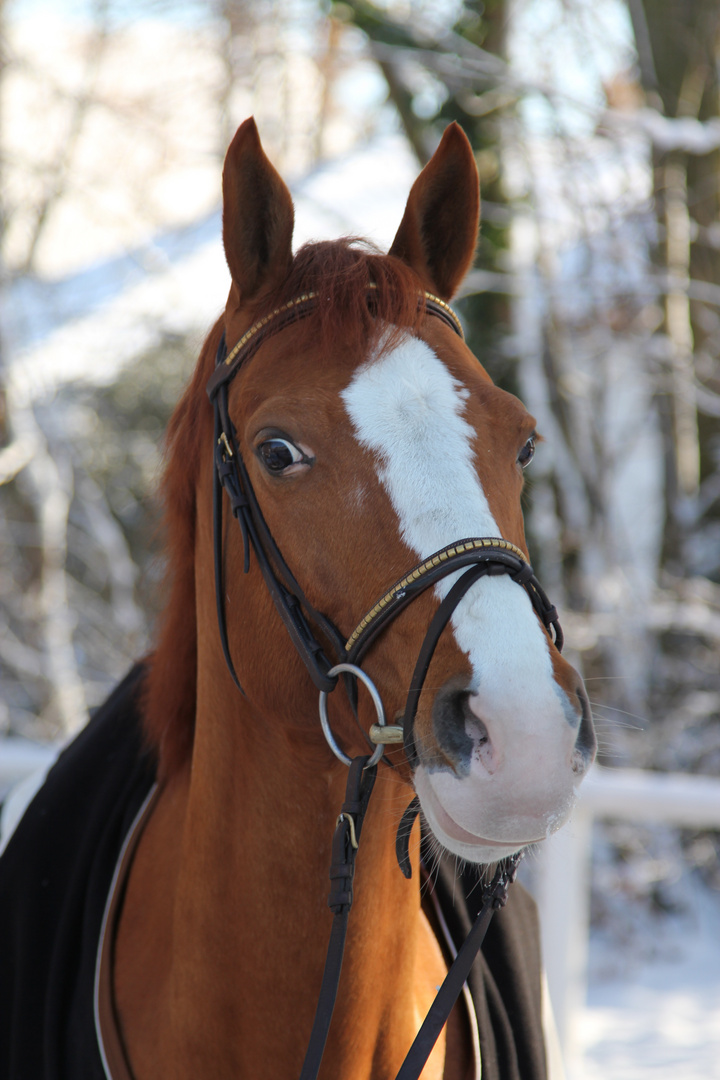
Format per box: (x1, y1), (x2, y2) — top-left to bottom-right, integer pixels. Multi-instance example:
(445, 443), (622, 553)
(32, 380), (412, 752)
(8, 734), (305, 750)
(144, 239), (431, 777)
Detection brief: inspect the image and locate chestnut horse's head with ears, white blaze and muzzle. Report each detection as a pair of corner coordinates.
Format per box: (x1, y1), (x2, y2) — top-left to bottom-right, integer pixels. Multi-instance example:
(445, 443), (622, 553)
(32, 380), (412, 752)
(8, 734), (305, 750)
(149, 113), (596, 863)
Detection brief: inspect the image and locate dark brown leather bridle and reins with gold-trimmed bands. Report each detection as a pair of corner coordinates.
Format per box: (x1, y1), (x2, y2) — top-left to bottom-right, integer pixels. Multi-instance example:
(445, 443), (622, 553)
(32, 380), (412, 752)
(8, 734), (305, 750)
(207, 292), (562, 1080)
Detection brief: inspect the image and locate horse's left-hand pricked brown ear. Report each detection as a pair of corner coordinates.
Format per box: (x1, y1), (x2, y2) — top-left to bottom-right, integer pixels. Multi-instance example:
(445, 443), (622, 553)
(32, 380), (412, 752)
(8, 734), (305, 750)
(222, 117), (295, 303)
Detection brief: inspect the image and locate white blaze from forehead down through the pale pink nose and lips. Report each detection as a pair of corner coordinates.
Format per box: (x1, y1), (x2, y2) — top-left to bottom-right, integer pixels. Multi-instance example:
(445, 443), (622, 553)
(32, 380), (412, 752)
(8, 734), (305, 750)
(341, 335), (575, 862)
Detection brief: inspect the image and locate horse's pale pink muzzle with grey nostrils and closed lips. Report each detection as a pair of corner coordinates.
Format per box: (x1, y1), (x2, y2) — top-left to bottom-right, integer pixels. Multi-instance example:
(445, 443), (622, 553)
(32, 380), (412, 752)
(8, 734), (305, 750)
(413, 665), (596, 863)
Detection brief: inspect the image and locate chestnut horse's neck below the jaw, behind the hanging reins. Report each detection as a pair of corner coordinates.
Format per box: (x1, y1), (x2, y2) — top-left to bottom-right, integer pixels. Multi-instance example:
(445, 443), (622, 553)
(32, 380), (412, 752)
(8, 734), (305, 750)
(162, 652), (443, 1080)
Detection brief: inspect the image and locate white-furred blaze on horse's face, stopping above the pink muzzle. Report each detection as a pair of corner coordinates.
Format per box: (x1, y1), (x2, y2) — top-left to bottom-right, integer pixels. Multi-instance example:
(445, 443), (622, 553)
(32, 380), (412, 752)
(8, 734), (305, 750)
(341, 336), (559, 713)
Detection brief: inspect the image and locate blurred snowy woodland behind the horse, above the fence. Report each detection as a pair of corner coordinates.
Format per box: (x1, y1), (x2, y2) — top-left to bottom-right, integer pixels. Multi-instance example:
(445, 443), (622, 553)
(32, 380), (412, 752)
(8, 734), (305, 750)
(0, 0), (720, 894)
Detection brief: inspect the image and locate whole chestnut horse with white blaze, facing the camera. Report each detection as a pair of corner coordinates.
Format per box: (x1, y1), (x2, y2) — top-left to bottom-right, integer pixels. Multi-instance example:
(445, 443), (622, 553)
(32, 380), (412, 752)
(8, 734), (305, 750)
(0, 121), (595, 1080)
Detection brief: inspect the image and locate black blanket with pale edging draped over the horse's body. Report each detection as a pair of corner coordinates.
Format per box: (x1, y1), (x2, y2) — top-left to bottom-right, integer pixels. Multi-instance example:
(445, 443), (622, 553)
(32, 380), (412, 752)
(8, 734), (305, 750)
(0, 666), (546, 1080)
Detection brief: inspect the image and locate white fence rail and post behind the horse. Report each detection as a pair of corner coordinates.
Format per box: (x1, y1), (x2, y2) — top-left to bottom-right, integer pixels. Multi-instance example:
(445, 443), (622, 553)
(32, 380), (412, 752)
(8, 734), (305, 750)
(0, 739), (720, 1055)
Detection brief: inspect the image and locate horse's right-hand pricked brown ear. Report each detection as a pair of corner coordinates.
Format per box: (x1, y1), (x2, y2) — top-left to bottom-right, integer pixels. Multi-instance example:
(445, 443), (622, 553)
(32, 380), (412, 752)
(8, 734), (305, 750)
(390, 123), (480, 300)
